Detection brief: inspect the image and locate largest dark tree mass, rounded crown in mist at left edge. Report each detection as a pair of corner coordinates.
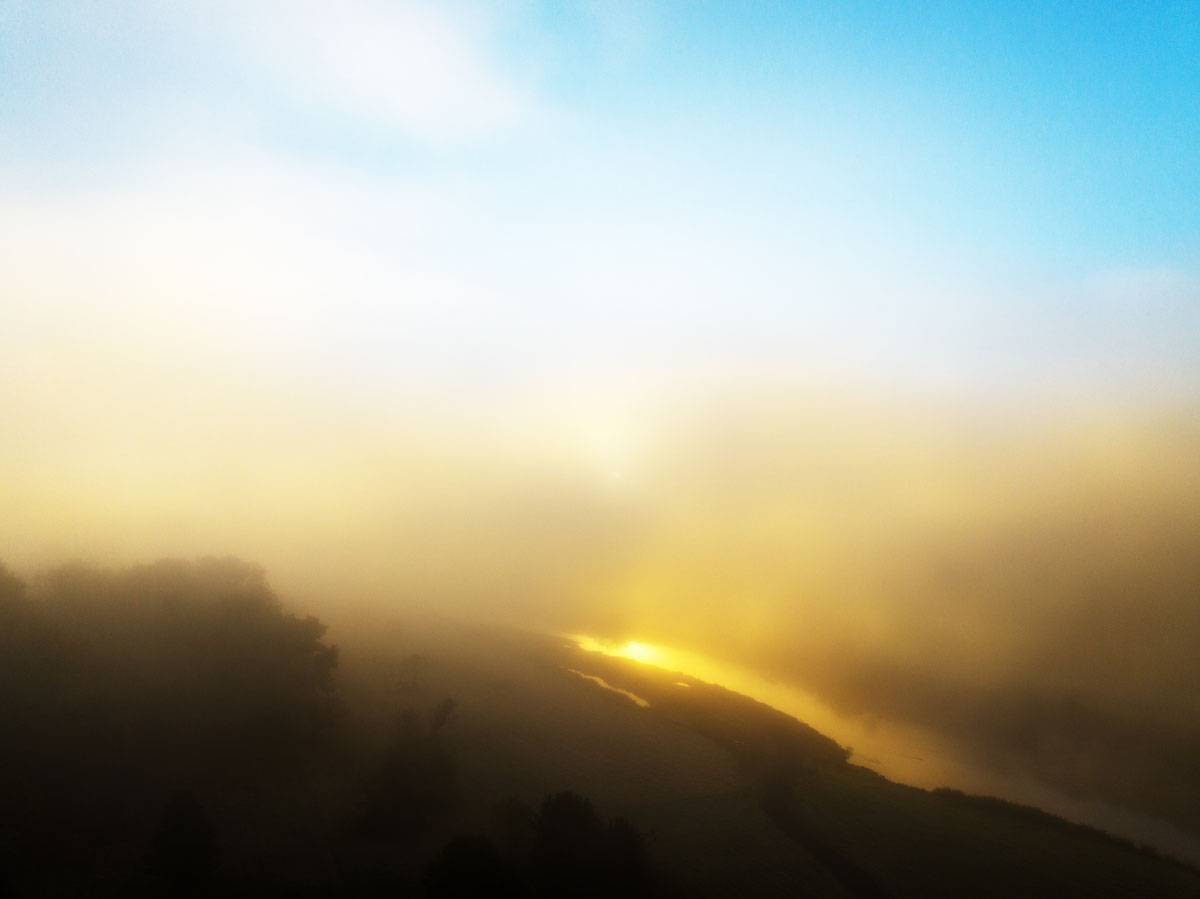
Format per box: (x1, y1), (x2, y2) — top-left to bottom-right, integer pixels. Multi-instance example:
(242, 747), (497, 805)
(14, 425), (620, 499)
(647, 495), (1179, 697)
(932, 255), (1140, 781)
(0, 559), (338, 891)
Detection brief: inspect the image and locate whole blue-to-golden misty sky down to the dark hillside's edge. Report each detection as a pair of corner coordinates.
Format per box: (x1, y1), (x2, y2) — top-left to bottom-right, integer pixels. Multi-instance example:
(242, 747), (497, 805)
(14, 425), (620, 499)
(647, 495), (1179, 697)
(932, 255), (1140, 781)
(7, 0), (1200, 855)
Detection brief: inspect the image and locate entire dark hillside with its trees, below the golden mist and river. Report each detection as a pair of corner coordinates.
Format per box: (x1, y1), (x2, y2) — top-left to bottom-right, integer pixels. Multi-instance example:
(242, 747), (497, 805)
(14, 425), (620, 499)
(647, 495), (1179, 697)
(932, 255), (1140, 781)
(0, 558), (1200, 899)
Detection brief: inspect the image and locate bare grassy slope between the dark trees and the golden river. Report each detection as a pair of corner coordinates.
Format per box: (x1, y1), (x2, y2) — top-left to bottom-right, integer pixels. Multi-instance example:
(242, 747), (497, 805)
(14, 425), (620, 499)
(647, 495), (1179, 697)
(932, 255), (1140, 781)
(340, 625), (1200, 897)
